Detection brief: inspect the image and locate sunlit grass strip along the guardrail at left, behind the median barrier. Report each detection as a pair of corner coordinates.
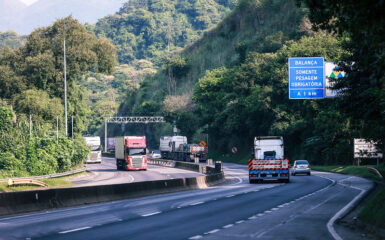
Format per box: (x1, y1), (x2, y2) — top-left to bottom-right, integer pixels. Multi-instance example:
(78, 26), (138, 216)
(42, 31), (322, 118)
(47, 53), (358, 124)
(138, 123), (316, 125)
(0, 172), (86, 192)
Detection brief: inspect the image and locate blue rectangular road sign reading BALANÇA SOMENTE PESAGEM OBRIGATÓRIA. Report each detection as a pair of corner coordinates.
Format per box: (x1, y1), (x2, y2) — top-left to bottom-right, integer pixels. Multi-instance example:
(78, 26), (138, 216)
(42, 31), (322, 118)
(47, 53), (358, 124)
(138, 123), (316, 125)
(289, 57), (325, 99)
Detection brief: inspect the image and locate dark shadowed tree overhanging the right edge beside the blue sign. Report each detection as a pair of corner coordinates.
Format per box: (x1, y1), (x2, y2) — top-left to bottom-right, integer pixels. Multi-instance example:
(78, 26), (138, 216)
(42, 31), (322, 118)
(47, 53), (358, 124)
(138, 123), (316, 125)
(298, 0), (385, 145)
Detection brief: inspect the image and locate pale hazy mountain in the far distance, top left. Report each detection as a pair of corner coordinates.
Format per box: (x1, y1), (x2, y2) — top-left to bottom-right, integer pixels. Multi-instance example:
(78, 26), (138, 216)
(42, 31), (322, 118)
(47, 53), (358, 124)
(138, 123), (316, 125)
(0, 0), (126, 35)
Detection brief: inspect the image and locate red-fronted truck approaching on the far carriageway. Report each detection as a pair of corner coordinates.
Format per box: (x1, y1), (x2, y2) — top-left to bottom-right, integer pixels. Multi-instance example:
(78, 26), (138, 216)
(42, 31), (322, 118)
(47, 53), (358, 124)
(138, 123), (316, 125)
(115, 136), (147, 170)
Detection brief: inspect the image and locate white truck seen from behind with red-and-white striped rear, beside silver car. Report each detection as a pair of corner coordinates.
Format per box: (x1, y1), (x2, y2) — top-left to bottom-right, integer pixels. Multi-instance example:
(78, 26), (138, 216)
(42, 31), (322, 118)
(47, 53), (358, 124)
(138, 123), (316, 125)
(249, 136), (290, 183)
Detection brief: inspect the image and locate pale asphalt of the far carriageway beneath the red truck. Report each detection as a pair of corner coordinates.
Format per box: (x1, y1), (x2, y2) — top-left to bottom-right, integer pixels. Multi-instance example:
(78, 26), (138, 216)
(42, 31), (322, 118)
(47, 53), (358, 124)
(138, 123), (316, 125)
(68, 157), (202, 186)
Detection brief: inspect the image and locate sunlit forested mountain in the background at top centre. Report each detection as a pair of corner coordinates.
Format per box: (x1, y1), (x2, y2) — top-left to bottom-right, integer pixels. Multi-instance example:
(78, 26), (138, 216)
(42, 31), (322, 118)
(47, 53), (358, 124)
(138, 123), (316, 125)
(94, 0), (235, 64)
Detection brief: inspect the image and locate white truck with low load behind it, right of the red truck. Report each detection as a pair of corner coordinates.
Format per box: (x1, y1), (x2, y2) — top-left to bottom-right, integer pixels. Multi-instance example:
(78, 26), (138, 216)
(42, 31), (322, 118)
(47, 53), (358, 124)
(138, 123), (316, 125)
(159, 136), (207, 162)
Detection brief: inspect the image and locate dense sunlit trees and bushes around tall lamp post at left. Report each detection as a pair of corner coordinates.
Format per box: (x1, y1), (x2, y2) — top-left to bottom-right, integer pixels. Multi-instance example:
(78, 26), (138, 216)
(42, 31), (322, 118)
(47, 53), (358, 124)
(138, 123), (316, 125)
(0, 17), (116, 175)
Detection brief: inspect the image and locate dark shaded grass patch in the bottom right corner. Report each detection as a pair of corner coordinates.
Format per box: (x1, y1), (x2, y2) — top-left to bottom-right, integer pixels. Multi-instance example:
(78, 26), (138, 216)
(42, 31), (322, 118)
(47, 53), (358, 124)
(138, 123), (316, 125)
(358, 187), (385, 229)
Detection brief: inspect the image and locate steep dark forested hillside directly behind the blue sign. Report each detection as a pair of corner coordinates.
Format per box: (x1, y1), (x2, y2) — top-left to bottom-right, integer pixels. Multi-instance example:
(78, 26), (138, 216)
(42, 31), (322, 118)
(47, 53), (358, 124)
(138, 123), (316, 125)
(115, 0), (355, 162)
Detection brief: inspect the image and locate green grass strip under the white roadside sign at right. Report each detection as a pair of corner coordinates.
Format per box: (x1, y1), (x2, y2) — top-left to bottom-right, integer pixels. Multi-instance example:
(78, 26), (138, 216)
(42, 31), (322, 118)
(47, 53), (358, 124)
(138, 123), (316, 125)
(311, 165), (384, 180)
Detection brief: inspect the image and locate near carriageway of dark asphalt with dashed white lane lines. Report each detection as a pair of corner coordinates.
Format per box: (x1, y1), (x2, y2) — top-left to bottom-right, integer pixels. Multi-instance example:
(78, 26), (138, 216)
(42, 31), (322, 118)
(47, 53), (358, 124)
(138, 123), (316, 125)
(0, 164), (372, 239)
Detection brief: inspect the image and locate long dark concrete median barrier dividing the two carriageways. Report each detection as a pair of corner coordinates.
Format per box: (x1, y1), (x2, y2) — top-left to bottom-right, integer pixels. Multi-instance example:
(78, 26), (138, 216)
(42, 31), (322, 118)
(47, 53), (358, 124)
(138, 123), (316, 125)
(0, 162), (224, 215)
